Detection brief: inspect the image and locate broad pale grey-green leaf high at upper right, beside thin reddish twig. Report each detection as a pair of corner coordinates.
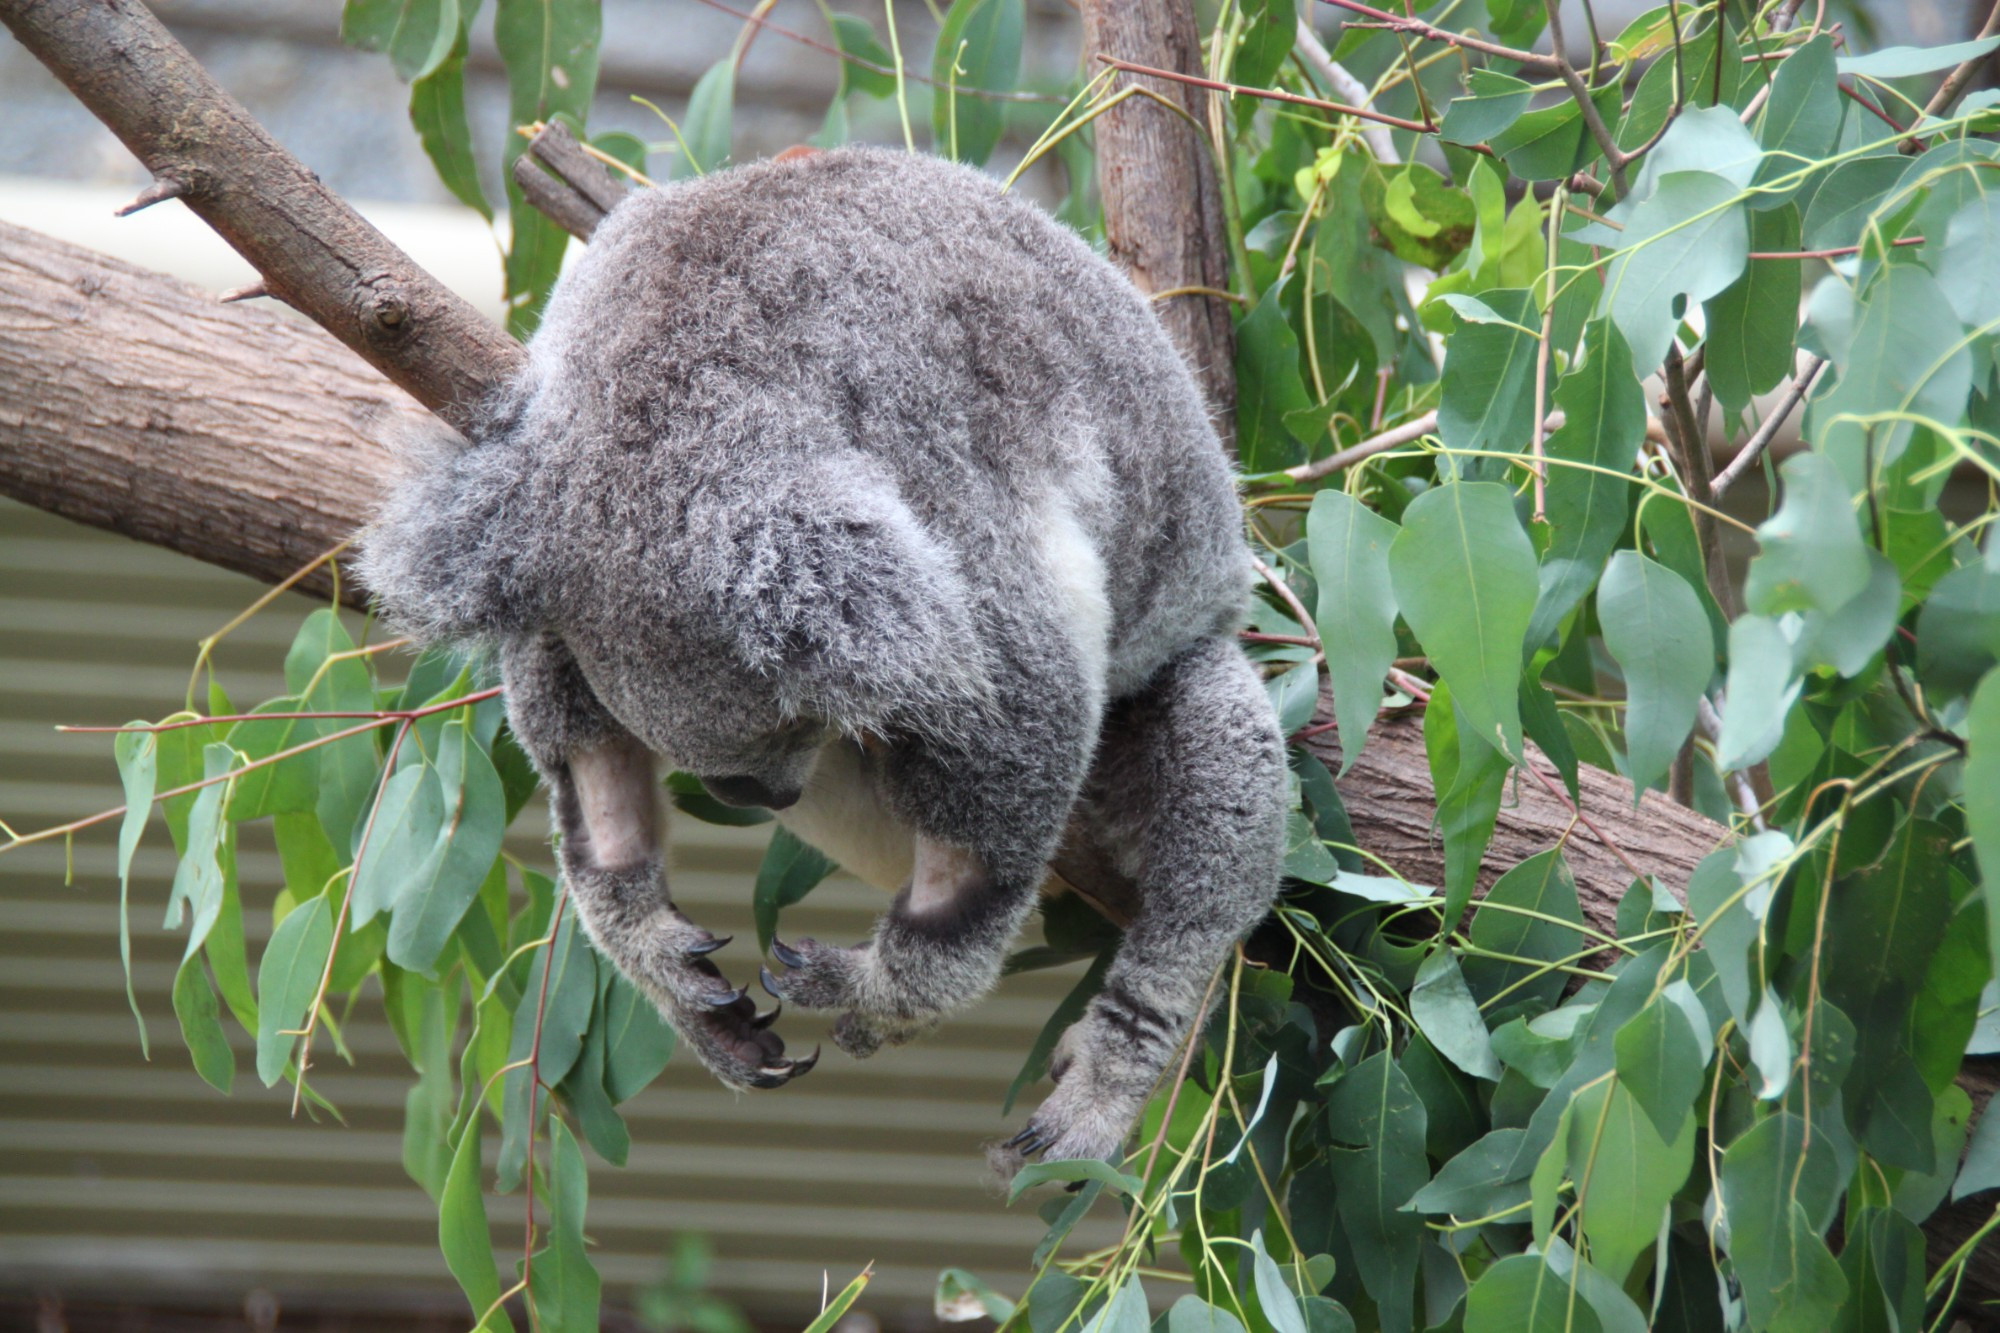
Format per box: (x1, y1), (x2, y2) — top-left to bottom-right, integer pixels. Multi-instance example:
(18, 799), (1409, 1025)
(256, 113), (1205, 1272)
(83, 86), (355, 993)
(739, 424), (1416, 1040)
(1598, 172), (1750, 376)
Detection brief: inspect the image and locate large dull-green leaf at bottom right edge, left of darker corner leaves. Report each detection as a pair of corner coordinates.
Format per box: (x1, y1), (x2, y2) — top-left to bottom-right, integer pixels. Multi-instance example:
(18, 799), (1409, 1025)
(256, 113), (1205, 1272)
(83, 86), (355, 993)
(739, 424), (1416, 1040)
(1720, 1111), (1848, 1333)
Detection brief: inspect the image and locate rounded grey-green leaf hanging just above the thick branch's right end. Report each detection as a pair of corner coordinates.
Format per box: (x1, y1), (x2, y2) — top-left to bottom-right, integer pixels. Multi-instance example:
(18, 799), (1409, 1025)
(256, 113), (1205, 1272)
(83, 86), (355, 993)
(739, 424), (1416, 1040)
(1598, 550), (1716, 805)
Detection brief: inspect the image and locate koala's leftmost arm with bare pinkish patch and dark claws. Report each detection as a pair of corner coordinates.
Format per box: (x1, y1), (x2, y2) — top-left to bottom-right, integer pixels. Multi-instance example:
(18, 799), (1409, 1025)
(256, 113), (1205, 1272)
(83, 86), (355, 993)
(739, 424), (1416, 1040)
(500, 636), (814, 1087)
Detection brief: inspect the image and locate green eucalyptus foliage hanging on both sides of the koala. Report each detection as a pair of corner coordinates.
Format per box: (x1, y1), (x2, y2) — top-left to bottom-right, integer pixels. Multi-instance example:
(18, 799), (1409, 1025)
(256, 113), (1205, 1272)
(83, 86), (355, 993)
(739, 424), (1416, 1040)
(11, 0), (2000, 1333)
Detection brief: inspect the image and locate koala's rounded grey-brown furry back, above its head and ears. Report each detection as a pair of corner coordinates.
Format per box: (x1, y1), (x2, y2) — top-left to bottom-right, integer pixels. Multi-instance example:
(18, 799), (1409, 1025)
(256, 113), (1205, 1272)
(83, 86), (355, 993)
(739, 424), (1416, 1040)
(514, 148), (1246, 693)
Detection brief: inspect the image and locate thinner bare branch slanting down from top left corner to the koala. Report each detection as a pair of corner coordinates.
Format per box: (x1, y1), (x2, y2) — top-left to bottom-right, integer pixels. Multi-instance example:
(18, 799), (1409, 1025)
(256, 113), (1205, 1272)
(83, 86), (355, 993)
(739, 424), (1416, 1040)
(0, 0), (522, 426)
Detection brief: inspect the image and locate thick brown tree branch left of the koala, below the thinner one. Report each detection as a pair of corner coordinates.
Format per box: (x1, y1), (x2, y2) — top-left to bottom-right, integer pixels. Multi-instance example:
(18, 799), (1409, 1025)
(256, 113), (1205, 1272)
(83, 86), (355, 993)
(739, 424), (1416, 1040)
(0, 224), (408, 604)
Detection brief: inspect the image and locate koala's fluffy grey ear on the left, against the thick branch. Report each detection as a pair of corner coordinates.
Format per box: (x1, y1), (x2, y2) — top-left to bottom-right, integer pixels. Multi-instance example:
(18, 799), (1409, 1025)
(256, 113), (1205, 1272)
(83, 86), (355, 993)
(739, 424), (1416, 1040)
(356, 422), (542, 642)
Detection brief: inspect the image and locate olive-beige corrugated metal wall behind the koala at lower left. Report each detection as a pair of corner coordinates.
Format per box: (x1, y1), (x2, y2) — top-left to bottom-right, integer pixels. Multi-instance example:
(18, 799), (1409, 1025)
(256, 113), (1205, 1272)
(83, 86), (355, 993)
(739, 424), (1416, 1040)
(0, 500), (1112, 1327)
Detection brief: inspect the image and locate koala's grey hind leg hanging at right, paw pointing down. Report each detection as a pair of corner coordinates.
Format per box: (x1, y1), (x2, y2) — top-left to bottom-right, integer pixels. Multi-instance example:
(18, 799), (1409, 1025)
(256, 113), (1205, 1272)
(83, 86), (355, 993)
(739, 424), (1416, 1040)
(990, 638), (1284, 1179)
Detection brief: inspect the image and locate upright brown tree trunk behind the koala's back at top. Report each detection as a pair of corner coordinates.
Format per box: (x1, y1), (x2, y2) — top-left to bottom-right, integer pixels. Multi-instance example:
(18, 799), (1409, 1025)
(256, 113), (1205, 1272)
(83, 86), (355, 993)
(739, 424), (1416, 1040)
(1082, 0), (1236, 440)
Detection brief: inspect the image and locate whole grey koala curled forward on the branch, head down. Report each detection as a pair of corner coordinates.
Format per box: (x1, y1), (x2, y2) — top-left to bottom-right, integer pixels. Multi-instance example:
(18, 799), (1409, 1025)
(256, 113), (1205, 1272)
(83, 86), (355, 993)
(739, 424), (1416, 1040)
(360, 148), (1284, 1173)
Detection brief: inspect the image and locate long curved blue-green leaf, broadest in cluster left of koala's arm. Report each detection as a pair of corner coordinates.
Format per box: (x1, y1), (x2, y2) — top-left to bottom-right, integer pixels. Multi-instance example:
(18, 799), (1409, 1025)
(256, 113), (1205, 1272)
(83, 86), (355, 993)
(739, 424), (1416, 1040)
(388, 719), (506, 975)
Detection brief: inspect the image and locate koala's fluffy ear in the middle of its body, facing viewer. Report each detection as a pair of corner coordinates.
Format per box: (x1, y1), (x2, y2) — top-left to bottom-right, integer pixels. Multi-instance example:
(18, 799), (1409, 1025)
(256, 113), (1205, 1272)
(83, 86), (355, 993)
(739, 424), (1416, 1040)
(690, 462), (986, 731)
